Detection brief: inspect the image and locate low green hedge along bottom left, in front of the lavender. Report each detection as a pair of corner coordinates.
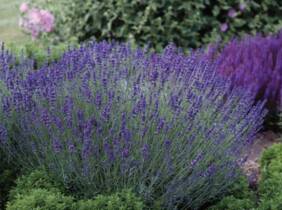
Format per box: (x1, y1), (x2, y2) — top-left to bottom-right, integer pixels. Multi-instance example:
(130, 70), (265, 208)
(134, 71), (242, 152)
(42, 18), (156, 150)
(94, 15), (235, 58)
(7, 170), (145, 210)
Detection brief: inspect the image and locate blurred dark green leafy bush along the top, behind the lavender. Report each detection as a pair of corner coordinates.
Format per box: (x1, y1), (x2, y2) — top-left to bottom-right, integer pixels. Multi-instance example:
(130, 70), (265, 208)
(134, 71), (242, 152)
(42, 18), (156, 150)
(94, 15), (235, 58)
(32, 0), (282, 49)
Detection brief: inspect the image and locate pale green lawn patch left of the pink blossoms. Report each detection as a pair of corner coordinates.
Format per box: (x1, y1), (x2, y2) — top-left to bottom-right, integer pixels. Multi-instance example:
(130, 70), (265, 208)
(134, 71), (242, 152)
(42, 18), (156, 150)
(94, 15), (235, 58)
(0, 0), (30, 44)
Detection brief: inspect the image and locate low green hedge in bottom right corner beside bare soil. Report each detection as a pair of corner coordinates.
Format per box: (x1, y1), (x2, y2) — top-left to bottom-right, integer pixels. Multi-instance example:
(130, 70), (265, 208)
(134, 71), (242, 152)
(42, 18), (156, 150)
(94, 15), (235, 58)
(210, 144), (282, 210)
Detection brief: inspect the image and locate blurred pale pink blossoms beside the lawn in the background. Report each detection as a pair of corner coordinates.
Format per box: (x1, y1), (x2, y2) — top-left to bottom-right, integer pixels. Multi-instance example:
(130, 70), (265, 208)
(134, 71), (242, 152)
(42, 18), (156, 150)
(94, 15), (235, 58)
(19, 3), (55, 39)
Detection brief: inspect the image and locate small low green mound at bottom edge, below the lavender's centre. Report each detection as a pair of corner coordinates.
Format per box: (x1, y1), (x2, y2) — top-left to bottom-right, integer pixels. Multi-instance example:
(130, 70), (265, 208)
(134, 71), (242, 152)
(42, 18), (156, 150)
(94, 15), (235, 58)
(77, 190), (144, 210)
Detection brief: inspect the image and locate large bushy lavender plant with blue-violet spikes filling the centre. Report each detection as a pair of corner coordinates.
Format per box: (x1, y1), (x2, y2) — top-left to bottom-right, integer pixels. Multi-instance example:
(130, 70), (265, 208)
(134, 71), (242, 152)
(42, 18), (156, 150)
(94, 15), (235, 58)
(0, 42), (265, 209)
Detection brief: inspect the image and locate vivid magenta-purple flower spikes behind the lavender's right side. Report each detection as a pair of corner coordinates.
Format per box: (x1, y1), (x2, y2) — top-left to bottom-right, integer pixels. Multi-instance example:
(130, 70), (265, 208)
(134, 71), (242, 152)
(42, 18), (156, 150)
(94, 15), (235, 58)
(218, 32), (282, 110)
